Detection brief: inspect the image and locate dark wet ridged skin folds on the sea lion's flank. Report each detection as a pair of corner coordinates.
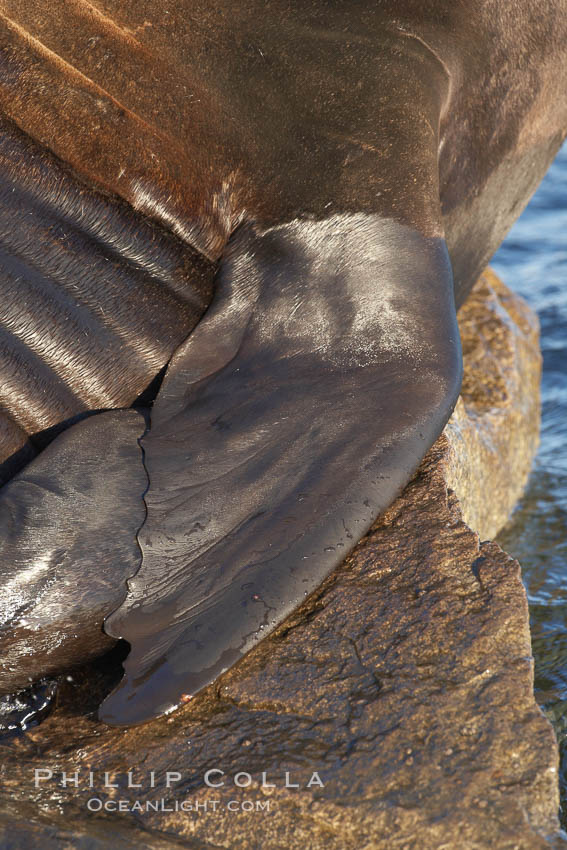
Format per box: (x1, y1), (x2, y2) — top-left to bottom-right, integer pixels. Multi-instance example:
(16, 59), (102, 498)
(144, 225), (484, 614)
(0, 121), (213, 483)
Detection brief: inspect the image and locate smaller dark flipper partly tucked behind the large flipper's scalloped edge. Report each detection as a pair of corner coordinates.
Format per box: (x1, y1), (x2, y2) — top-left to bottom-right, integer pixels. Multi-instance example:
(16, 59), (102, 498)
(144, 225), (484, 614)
(0, 410), (147, 694)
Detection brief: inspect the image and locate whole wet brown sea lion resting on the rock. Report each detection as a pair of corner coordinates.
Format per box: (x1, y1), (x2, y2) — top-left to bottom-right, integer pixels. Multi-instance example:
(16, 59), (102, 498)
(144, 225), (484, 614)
(0, 0), (567, 724)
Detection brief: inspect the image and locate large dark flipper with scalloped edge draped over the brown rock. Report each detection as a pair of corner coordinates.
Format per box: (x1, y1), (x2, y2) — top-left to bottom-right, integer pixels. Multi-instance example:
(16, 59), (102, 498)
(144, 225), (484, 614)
(101, 214), (461, 725)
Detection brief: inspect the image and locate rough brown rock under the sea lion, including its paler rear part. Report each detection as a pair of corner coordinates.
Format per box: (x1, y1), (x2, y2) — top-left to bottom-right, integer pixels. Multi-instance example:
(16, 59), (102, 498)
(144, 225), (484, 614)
(0, 275), (567, 850)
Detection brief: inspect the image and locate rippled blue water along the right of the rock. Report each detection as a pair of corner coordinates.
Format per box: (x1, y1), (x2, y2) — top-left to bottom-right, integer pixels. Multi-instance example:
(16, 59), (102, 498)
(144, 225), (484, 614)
(491, 143), (567, 826)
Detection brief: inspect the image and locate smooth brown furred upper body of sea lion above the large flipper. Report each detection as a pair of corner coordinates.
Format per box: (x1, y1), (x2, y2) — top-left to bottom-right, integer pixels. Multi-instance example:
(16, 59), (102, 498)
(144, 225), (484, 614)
(0, 0), (565, 292)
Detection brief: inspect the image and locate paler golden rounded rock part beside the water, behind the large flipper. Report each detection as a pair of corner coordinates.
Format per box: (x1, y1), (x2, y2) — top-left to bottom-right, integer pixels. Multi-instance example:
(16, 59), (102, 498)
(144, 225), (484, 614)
(444, 269), (541, 540)
